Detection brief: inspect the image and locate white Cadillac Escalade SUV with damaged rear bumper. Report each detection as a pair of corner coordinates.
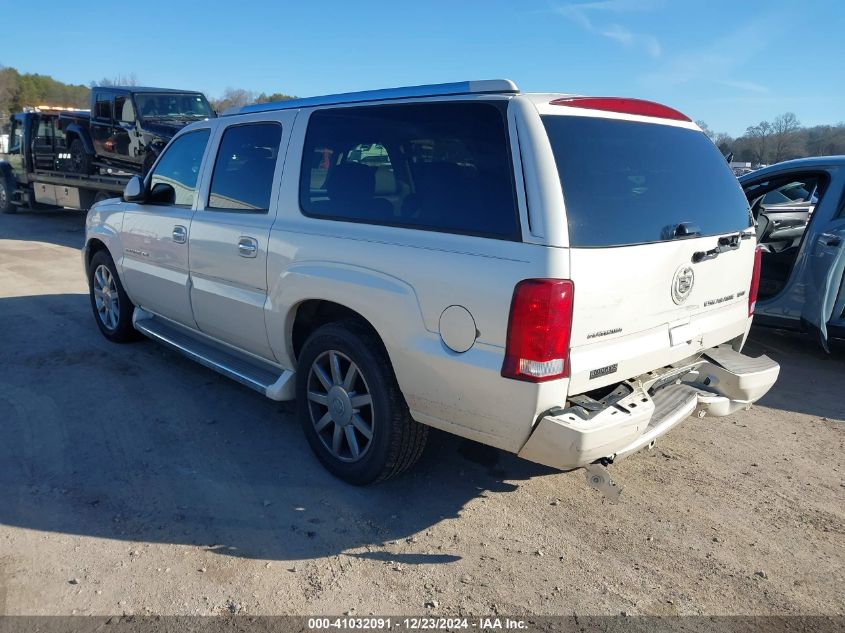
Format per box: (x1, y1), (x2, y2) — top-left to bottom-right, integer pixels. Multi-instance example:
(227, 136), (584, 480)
(84, 80), (779, 484)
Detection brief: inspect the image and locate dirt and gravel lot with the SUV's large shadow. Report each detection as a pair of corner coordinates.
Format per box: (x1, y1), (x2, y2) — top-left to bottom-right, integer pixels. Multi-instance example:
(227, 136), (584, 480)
(0, 212), (845, 615)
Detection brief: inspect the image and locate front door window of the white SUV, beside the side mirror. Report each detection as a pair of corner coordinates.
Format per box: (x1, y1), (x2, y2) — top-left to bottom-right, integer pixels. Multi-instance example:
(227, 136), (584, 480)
(149, 128), (209, 207)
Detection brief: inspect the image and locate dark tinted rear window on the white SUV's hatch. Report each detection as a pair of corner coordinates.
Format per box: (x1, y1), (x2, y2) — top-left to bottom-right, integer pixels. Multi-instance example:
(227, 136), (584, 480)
(542, 116), (751, 247)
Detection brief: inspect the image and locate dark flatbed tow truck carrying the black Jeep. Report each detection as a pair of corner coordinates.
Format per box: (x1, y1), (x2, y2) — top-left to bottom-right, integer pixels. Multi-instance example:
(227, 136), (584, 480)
(0, 106), (133, 213)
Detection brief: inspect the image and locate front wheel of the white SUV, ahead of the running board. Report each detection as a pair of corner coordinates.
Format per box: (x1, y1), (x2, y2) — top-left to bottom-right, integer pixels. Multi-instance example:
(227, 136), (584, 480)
(88, 251), (140, 343)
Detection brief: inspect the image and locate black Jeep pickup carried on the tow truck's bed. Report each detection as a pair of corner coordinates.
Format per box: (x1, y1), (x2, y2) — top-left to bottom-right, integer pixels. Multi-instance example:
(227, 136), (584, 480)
(59, 86), (217, 175)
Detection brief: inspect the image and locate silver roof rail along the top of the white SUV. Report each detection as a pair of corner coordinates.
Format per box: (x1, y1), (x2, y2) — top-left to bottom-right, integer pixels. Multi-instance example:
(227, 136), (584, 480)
(223, 79), (519, 116)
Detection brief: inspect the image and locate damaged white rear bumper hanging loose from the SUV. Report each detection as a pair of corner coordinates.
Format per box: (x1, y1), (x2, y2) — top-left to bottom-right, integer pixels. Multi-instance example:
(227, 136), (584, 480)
(519, 345), (780, 469)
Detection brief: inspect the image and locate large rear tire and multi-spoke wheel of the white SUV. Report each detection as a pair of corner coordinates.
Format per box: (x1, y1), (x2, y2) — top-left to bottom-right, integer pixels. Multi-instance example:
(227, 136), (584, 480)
(296, 321), (428, 486)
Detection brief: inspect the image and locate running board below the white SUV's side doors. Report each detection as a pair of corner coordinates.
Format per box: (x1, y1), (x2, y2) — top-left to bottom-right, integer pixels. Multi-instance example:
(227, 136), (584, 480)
(132, 308), (295, 400)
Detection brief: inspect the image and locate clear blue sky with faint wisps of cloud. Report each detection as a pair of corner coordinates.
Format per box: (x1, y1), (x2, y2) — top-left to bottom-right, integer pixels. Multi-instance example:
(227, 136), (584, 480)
(0, 0), (845, 135)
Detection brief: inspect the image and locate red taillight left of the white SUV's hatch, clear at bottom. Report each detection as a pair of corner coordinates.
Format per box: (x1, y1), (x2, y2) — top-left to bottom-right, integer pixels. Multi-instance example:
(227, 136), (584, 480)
(502, 279), (575, 382)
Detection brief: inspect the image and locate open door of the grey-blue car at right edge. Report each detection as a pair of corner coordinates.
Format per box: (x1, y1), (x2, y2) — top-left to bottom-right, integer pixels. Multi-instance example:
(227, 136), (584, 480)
(801, 218), (845, 351)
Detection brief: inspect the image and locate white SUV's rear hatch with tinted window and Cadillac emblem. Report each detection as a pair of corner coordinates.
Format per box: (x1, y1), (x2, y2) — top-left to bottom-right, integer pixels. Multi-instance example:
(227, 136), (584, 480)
(542, 108), (755, 394)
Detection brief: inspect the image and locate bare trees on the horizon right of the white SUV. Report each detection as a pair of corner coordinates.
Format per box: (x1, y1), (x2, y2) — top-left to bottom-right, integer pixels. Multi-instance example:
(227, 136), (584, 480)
(696, 112), (845, 166)
